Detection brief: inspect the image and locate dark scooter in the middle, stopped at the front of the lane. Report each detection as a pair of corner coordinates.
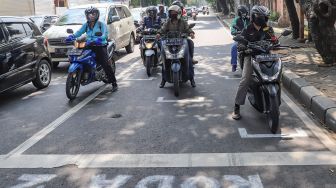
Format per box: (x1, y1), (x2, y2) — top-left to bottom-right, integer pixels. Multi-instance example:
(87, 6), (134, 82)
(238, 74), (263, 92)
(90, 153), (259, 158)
(161, 24), (195, 97)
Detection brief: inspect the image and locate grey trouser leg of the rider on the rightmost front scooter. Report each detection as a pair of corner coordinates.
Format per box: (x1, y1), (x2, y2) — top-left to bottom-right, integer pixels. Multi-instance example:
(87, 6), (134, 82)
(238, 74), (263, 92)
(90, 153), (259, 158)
(235, 56), (253, 105)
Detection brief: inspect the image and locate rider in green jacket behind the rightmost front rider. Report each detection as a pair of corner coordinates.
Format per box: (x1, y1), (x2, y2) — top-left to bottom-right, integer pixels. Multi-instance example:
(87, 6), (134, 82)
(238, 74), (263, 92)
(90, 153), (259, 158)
(231, 5), (250, 72)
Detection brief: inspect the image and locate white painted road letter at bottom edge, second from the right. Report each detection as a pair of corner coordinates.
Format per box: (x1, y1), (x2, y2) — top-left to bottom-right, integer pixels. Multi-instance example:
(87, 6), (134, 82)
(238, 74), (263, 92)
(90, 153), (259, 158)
(181, 176), (221, 188)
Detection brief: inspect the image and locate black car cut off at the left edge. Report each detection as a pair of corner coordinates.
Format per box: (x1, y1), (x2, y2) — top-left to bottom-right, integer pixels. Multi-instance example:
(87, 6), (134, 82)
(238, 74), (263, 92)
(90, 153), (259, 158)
(0, 16), (51, 93)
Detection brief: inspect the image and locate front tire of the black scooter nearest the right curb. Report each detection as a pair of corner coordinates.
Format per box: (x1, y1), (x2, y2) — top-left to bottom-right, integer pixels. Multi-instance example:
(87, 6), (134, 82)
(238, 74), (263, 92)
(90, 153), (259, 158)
(267, 97), (280, 134)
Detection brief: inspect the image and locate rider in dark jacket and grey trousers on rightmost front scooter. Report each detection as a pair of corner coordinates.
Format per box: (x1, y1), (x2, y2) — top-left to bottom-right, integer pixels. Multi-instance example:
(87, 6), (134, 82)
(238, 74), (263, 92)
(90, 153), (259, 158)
(232, 5), (277, 120)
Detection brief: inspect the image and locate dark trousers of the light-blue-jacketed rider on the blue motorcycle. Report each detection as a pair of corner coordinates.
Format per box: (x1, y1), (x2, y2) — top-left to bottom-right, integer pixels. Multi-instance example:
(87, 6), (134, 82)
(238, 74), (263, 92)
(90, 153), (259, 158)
(90, 46), (117, 83)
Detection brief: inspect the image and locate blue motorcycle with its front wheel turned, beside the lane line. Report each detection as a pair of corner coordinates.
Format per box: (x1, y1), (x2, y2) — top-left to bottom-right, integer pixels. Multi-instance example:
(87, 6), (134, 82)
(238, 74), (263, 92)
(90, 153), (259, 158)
(65, 29), (116, 100)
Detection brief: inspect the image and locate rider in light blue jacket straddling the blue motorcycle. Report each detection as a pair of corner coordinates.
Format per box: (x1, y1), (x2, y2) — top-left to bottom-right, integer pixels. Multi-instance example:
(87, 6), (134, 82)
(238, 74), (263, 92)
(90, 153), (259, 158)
(66, 7), (118, 92)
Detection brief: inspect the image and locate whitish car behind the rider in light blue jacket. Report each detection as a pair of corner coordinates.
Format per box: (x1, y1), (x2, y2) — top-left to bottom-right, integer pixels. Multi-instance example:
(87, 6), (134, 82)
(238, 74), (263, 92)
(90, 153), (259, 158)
(44, 3), (136, 67)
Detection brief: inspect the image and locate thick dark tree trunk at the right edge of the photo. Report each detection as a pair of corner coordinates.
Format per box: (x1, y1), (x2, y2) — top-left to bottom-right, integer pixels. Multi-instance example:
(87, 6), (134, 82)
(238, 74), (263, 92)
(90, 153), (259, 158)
(310, 0), (336, 64)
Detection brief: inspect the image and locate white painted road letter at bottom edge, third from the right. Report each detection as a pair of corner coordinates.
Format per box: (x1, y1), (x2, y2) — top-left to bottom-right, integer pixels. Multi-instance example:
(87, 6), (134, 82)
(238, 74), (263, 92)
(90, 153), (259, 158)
(135, 175), (175, 188)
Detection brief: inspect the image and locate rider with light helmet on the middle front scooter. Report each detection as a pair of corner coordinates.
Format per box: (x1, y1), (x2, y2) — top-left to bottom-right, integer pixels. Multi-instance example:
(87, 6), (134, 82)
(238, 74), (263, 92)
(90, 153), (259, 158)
(157, 5), (198, 88)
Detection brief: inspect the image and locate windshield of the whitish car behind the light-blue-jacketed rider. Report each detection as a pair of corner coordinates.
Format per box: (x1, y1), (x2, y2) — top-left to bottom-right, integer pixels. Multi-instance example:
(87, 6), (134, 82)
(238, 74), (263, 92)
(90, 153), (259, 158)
(55, 8), (106, 26)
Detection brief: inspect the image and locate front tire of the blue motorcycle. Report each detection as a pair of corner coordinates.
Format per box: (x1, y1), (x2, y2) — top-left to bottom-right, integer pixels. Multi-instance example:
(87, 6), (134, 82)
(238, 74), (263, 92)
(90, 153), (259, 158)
(65, 70), (81, 100)
